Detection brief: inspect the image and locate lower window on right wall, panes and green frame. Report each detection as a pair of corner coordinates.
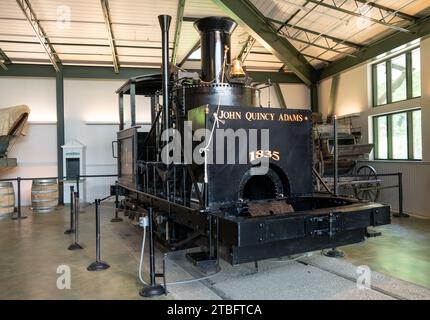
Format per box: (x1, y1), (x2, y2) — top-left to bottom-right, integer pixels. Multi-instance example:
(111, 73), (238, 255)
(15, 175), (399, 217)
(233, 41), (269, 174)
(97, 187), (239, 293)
(373, 109), (422, 160)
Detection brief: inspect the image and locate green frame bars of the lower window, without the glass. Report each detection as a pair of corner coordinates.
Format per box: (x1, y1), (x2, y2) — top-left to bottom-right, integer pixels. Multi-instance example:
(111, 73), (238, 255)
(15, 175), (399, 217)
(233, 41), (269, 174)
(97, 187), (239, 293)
(372, 108), (422, 161)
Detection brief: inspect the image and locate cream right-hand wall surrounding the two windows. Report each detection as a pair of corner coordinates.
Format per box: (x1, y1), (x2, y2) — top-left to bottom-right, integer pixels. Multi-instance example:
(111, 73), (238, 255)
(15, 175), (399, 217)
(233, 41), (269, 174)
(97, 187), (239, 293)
(319, 39), (430, 218)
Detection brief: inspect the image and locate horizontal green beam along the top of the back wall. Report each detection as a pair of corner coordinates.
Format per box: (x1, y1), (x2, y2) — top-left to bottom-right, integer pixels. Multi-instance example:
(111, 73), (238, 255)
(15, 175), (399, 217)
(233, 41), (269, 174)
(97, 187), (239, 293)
(0, 63), (303, 83)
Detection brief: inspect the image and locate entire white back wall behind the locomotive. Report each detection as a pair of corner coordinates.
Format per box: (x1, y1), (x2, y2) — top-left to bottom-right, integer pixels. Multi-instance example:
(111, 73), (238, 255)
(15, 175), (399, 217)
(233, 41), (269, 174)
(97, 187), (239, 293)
(0, 77), (310, 205)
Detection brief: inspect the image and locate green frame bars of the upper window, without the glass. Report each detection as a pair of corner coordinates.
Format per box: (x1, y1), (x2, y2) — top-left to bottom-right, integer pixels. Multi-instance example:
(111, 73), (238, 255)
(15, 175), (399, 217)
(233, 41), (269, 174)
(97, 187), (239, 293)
(372, 46), (421, 108)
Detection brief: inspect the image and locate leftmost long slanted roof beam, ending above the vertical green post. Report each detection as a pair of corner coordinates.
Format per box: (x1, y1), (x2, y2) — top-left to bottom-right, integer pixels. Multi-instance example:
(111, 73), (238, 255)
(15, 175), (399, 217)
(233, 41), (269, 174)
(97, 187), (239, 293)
(16, 0), (62, 72)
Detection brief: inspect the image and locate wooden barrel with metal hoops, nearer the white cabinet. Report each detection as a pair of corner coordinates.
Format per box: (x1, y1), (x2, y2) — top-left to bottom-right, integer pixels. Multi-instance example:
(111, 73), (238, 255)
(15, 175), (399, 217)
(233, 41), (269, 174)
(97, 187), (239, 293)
(31, 179), (58, 213)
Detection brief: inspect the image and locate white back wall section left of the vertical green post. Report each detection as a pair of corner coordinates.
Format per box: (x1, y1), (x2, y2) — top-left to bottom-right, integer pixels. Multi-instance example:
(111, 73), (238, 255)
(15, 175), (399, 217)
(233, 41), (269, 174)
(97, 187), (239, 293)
(0, 77), (57, 205)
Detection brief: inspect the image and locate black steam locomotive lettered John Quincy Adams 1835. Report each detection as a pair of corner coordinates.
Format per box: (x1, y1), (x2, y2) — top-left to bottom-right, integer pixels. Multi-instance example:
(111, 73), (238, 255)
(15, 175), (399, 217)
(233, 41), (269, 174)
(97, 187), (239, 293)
(113, 16), (390, 265)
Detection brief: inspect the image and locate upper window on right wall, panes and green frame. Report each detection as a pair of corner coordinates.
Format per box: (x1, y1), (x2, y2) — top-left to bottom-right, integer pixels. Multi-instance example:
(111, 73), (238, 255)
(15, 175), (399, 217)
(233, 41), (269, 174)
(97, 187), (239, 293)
(372, 48), (421, 107)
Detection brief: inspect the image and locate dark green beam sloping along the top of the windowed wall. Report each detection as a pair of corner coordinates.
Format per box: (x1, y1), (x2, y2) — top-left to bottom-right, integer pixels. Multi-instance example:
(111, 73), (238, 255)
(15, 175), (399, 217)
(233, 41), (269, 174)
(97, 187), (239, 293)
(318, 16), (430, 80)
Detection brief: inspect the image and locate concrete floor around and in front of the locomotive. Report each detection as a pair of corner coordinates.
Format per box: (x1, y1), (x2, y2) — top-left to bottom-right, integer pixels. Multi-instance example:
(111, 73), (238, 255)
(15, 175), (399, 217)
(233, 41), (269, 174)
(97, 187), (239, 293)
(0, 204), (430, 299)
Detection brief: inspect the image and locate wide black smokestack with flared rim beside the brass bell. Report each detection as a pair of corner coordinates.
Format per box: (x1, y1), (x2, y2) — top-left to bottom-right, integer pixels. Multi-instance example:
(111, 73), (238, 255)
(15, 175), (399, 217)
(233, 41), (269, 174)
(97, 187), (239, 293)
(194, 17), (237, 83)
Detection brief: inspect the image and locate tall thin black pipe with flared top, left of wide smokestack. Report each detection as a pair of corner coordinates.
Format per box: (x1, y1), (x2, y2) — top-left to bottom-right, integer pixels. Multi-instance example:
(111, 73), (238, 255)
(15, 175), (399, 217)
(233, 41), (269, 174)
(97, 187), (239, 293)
(158, 15), (172, 135)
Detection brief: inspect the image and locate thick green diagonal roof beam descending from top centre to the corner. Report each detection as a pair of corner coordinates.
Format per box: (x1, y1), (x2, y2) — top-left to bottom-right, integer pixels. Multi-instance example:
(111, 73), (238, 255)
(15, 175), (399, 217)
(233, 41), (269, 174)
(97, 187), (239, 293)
(213, 0), (315, 85)
